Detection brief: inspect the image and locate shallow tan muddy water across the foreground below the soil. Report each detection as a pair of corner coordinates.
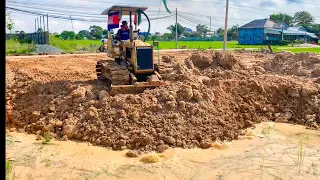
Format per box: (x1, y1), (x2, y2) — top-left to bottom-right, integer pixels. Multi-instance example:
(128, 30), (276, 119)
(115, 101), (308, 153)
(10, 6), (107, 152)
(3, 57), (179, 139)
(6, 123), (320, 180)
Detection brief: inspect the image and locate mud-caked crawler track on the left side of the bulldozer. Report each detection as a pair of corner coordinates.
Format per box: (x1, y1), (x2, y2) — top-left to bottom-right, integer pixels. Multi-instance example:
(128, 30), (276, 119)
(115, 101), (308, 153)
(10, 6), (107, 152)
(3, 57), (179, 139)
(96, 60), (129, 85)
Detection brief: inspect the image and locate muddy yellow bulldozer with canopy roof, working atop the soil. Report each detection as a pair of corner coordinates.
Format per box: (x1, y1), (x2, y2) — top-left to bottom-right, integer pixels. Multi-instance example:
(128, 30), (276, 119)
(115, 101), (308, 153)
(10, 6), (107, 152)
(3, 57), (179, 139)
(96, 5), (164, 93)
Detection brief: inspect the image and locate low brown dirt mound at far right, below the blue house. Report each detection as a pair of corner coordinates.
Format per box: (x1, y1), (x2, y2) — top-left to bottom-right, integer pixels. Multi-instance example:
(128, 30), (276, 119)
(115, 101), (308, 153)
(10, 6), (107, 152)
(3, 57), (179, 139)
(262, 52), (320, 77)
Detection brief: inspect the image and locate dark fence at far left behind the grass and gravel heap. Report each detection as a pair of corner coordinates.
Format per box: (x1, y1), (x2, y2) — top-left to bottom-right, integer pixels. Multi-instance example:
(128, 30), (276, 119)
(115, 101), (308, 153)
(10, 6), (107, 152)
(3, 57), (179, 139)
(6, 31), (49, 44)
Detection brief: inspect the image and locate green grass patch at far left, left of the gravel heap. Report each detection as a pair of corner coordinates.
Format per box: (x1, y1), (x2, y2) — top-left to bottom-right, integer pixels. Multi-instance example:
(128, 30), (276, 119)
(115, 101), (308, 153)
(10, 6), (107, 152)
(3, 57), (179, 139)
(6, 40), (36, 55)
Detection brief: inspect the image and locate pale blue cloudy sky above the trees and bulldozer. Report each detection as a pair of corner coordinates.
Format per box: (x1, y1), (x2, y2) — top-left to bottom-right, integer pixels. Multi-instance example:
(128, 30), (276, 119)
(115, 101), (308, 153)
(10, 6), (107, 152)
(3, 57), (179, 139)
(6, 0), (320, 33)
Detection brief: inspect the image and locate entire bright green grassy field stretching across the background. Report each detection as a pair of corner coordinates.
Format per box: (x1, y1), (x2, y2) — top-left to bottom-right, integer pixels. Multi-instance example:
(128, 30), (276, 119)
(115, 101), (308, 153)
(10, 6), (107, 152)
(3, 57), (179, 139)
(6, 36), (320, 55)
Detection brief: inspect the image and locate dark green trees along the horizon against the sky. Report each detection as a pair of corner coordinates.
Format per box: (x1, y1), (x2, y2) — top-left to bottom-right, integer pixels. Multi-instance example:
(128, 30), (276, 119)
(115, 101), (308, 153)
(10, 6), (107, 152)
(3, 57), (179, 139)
(6, 11), (320, 40)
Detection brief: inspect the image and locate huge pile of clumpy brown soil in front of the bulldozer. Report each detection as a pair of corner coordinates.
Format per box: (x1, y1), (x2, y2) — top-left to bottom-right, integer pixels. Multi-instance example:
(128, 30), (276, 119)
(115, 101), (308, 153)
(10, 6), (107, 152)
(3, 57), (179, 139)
(6, 51), (320, 152)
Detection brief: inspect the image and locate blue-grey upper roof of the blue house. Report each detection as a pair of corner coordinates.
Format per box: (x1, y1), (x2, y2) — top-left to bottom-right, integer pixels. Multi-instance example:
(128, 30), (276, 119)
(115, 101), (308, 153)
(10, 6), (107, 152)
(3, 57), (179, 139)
(239, 19), (282, 29)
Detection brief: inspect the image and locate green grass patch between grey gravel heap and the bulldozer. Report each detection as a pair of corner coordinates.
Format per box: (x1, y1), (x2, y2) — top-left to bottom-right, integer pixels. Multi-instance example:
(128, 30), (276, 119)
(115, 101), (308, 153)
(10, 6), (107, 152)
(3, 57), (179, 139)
(49, 36), (101, 52)
